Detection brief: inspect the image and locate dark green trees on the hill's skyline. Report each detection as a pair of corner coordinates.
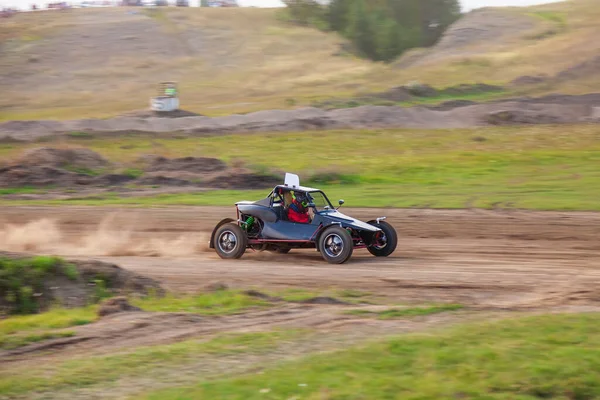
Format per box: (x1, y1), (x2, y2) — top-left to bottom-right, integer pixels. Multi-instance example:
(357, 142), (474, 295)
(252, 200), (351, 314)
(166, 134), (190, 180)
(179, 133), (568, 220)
(285, 0), (460, 61)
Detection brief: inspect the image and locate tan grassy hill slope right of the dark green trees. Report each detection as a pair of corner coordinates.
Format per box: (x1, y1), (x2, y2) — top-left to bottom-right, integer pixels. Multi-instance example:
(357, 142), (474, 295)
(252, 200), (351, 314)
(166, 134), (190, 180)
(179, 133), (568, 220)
(396, 0), (600, 94)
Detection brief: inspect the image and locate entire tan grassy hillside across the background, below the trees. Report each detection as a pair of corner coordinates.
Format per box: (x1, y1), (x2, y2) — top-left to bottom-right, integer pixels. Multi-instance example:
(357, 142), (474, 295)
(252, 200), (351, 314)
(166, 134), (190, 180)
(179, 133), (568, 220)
(0, 0), (600, 120)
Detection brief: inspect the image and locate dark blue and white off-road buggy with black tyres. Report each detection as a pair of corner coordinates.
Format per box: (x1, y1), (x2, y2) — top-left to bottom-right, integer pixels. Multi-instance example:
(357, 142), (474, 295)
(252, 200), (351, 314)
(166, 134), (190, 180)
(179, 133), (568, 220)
(209, 173), (398, 264)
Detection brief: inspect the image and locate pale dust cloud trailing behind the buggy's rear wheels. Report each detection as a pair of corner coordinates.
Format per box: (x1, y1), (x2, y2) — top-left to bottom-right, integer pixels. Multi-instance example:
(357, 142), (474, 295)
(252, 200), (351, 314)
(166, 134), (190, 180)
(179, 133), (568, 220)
(0, 213), (209, 257)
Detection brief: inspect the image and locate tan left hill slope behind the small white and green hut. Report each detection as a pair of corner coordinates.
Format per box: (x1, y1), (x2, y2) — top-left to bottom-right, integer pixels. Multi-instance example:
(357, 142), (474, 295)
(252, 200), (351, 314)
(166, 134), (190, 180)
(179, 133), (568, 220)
(0, 8), (373, 119)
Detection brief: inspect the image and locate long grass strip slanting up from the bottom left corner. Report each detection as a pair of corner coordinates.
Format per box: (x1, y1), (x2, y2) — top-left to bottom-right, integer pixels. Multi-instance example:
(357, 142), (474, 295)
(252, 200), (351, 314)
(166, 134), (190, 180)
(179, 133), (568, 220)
(0, 330), (301, 396)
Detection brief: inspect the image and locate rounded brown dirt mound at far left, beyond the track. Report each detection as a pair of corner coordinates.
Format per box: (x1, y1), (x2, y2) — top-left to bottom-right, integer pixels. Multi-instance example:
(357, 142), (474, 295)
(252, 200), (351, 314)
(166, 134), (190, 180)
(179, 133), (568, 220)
(18, 147), (109, 170)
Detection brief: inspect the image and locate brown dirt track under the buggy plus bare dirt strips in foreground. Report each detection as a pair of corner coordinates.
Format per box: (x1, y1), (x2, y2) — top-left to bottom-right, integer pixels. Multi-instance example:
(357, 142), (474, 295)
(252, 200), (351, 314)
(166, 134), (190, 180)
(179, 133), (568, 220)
(0, 207), (600, 399)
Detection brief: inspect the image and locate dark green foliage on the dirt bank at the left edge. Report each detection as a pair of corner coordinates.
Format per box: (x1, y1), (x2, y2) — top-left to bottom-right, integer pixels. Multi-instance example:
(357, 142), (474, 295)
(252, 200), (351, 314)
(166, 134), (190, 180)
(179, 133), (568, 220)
(0, 256), (78, 314)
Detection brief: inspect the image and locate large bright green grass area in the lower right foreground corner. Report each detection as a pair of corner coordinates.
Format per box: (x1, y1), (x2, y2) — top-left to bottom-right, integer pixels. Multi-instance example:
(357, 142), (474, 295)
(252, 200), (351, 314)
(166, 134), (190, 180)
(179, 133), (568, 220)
(138, 314), (600, 400)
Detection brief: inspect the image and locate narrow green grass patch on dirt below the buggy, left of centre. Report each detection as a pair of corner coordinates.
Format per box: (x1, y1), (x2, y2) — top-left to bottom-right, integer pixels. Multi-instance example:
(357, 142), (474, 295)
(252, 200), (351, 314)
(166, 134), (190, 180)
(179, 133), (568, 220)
(131, 290), (271, 315)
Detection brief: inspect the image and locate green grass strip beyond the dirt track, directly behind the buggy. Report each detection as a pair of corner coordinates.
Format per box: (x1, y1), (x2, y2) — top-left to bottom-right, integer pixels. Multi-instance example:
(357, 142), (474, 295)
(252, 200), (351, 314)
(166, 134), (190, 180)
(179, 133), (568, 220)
(0, 125), (600, 210)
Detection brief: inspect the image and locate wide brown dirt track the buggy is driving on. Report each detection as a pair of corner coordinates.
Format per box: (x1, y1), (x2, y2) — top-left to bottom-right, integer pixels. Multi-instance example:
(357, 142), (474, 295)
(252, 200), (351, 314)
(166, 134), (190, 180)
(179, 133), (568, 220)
(0, 207), (600, 309)
